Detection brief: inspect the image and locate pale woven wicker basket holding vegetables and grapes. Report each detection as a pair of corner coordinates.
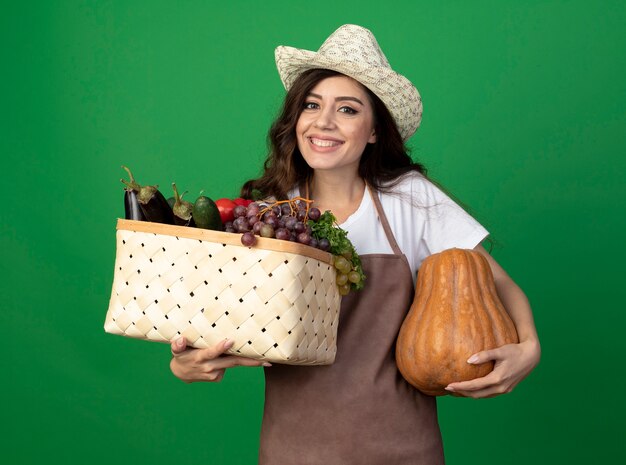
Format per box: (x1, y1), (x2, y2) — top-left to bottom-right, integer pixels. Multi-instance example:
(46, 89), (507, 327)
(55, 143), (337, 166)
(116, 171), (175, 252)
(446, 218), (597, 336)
(104, 219), (341, 365)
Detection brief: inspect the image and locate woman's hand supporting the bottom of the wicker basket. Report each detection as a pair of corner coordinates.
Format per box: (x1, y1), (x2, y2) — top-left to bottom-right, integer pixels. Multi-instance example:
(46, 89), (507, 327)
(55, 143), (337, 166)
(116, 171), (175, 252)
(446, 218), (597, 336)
(170, 337), (271, 383)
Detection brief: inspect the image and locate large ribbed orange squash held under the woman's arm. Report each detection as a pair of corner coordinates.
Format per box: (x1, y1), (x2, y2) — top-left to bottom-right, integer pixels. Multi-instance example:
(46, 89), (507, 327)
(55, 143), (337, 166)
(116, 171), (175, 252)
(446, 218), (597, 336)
(396, 249), (518, 396)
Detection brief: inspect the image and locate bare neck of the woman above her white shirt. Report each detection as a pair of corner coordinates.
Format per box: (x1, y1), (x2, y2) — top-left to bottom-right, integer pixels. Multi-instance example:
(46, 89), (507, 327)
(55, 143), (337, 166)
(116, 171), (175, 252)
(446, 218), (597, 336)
(309, 172), (365, 224)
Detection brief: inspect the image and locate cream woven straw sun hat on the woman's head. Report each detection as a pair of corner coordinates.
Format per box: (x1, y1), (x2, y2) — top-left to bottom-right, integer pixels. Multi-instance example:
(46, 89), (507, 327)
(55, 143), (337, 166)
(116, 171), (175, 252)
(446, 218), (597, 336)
(275, 24), (422, 141)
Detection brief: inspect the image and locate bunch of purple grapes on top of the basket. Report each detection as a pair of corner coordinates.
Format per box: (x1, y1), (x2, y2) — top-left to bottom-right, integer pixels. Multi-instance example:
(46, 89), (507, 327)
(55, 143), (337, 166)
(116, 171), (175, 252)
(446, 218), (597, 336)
(224, 197), (330, 252)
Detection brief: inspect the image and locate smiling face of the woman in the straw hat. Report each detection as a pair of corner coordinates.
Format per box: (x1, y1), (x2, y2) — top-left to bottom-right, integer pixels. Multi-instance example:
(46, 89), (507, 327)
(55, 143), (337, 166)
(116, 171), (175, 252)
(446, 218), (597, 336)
(296, 76), (376, 177)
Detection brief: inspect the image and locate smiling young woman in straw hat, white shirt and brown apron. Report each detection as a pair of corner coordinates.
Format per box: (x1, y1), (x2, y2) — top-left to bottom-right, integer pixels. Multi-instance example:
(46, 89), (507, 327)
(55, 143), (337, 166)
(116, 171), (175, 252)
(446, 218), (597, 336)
(171, 25), (540, 465)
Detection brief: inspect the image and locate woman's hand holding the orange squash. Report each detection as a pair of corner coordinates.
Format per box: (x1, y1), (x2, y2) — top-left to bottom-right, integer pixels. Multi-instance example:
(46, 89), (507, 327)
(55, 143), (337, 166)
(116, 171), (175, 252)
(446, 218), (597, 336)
(446, 341), (540, 399)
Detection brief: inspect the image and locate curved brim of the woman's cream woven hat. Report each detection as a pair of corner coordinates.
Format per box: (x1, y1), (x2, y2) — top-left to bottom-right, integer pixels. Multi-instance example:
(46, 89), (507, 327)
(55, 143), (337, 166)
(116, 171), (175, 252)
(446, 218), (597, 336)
(275, 46), (422, 141)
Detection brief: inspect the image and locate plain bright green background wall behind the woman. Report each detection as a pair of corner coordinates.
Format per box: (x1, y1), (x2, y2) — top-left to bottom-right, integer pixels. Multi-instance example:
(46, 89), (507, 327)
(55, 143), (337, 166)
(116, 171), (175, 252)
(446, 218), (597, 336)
(0, 0), (626, 465)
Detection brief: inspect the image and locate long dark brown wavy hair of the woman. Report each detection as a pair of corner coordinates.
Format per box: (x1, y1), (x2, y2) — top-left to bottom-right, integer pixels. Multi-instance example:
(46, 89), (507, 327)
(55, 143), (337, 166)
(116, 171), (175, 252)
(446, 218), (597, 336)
(241, 69), (426, 199)
